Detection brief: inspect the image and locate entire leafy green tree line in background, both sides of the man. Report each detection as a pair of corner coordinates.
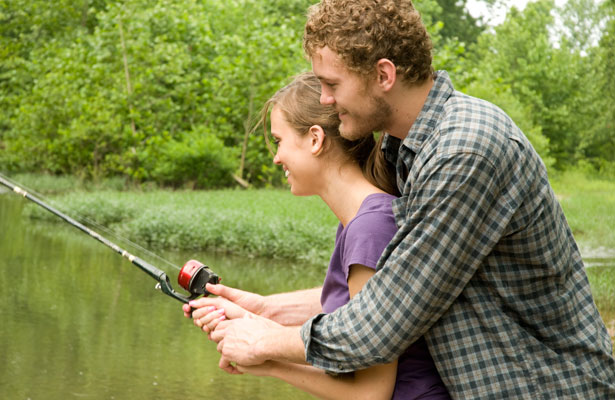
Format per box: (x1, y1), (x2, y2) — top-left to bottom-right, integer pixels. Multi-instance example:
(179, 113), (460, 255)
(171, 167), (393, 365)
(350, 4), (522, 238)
(0, 0), (615, 184)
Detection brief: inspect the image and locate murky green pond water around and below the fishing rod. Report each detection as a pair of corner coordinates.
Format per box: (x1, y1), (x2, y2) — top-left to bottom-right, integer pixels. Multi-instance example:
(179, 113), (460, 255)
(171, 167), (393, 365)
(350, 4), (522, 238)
(0, 193), (324, 400)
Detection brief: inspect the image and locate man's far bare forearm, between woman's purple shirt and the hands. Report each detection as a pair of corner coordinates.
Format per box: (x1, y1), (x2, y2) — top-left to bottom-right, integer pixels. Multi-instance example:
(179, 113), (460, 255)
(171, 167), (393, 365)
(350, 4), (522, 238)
(260, 288), (322, 326)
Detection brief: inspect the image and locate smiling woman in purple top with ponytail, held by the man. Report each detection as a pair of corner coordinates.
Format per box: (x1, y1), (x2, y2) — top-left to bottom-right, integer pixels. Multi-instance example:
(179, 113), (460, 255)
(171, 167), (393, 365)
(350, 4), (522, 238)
(184, 73), (449, 399)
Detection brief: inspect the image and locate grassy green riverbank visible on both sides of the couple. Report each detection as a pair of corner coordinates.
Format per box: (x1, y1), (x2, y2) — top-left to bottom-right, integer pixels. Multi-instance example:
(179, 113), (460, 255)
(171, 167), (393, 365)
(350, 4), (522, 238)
(7, 172), (615, 265)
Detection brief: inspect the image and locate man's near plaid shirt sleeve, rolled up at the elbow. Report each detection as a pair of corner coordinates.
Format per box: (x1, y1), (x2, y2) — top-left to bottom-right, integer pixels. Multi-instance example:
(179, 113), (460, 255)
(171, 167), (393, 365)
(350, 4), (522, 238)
(301, 152), (515, 373)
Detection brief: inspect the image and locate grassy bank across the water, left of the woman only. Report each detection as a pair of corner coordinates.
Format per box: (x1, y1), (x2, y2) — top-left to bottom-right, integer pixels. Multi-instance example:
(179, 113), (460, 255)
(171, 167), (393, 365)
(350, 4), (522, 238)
(27, 189), (337, 264)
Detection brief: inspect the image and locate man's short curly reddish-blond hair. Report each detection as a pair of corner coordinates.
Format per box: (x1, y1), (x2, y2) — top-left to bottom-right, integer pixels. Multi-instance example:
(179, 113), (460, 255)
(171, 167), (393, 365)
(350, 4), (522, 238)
(303, 0), (434, 84)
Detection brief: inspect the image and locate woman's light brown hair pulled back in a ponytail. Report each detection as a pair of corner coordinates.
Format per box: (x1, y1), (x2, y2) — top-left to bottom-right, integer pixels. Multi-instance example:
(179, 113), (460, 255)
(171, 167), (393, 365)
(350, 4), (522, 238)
(259, 72), (399, 196)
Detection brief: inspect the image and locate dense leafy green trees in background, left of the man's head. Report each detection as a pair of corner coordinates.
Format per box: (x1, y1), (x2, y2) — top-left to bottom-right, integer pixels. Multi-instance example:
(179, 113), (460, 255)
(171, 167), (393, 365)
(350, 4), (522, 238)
(0, 0), (308, 187)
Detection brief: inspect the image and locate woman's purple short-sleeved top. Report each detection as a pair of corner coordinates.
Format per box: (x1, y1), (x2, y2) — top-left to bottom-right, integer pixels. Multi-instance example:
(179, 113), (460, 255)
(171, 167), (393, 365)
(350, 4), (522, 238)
(320, 193), (450, 400)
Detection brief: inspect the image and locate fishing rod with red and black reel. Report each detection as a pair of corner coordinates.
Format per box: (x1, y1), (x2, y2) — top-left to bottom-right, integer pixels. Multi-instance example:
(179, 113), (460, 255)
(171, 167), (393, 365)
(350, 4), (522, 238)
(0, 175), (220, 303)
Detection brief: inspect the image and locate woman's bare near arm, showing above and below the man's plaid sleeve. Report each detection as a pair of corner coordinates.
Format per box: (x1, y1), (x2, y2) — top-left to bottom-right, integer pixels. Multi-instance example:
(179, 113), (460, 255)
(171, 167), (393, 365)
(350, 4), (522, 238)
(237, 265), (397, 399)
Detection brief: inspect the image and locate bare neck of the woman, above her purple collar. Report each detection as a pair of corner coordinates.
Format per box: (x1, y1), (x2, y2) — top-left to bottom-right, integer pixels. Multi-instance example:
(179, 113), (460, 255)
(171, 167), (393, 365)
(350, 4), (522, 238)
(318, 164), (384, 227)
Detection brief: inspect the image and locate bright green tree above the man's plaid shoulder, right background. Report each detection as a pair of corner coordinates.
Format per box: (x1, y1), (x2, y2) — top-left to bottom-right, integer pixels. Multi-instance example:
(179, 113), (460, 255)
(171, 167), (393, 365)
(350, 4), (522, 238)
(466, 0), (608, 169)
